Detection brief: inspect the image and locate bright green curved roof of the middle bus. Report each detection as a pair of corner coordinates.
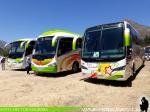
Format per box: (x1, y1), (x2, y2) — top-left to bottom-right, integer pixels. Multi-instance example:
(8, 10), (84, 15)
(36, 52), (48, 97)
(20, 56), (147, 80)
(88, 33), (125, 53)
(39, 30), (80, 37)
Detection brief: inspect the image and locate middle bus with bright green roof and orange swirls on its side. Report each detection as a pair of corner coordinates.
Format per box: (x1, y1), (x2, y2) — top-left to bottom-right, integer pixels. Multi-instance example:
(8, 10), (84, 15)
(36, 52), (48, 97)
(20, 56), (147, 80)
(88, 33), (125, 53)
(32, 30), (81, 73)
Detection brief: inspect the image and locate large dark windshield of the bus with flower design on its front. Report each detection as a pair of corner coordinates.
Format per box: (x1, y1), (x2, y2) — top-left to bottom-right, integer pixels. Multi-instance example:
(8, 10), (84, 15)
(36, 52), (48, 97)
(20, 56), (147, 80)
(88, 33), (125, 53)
(82, 27), (125, 59)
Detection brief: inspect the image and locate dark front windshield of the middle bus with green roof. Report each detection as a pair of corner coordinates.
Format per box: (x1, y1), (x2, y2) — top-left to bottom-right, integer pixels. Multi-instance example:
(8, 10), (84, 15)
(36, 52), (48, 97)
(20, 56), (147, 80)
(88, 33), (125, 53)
(33, 36), (56, 57)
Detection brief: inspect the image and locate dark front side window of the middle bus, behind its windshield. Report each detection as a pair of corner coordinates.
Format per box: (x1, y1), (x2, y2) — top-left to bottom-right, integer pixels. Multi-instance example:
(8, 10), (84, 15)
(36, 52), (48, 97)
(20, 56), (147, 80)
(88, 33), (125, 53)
(57, 38), (73, 56)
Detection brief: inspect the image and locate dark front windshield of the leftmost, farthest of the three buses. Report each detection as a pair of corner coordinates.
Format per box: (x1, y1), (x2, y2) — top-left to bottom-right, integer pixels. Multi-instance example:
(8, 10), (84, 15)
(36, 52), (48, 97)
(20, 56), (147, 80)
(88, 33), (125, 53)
(9, 41), (25, 59)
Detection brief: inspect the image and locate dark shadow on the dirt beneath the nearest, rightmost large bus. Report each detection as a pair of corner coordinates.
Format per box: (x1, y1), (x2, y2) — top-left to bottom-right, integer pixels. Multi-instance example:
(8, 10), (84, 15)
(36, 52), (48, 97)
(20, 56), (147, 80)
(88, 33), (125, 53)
(81, 66), (144, 87)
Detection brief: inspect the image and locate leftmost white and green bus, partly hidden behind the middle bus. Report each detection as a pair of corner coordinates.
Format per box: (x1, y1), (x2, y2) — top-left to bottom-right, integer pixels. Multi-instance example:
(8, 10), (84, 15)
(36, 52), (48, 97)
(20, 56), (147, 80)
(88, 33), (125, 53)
(6, 39), (36, 69)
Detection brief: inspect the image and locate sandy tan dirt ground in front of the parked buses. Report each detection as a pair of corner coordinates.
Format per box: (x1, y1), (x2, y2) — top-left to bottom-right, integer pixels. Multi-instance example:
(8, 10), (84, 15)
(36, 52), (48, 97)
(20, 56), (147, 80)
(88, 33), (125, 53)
(0, 62), (150, 108)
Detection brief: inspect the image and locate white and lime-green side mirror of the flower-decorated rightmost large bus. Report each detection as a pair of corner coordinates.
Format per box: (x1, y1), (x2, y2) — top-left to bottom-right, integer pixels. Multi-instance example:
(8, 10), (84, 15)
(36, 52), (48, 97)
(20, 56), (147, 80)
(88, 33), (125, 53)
(124, 28), (131, 46)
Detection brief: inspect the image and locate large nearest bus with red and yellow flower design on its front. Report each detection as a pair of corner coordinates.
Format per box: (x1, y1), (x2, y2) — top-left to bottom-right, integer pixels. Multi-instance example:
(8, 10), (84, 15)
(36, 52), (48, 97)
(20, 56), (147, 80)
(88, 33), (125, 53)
(81, 21), (144, 81)
